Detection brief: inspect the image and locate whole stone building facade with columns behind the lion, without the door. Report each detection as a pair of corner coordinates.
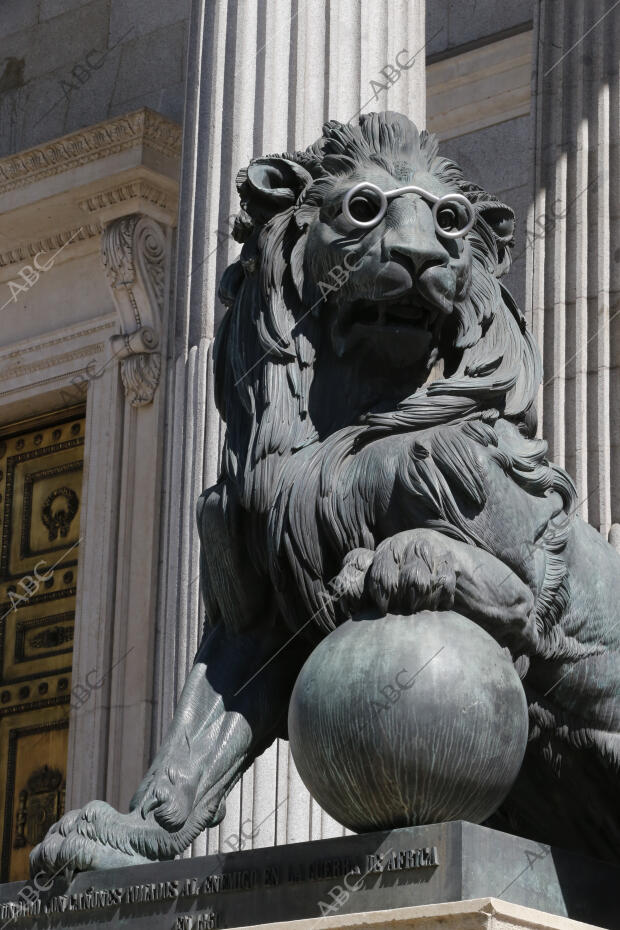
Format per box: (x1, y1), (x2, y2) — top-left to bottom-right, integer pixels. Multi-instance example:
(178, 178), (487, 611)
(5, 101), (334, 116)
(0, 0), (620, 880)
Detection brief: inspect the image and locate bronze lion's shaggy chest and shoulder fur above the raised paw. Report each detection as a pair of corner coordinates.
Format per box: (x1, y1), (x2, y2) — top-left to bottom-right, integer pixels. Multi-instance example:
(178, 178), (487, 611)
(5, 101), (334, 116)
(268, 421), (563, 628)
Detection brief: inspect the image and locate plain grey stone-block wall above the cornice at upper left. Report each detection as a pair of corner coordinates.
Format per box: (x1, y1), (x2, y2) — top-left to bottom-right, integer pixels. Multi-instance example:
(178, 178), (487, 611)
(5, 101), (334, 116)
(0, 0), (190, 157)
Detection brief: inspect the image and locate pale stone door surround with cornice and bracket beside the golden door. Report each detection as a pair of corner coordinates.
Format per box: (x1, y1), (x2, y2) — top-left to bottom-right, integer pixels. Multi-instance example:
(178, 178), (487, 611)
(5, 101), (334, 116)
(0, 109), (181, 836)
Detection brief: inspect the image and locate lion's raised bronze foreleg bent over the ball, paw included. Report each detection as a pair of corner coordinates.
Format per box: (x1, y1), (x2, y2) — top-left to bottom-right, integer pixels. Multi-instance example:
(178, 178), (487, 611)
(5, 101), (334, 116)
(333, 529), (538, 653)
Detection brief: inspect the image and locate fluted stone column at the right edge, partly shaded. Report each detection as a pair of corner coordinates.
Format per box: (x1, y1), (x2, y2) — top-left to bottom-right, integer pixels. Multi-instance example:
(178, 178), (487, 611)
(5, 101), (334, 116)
(528, 0), (620, 542)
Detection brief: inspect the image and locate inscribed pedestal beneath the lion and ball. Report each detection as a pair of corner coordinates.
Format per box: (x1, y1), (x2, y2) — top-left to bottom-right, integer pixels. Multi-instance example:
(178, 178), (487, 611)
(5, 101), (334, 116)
(0, 822), (620, 930)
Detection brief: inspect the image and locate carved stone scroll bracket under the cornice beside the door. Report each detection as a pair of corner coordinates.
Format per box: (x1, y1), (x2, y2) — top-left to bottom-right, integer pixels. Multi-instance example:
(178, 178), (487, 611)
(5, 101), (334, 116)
(101, 219), (167, 407)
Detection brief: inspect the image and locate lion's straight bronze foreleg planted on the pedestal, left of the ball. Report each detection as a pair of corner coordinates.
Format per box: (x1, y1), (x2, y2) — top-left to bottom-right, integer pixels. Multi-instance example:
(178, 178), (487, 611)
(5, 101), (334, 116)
(31, 626), (305, 875)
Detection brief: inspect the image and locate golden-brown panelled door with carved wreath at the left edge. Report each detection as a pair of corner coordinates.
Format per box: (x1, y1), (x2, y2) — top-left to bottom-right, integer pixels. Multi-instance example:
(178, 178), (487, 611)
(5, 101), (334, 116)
(0, 408), (84, 881)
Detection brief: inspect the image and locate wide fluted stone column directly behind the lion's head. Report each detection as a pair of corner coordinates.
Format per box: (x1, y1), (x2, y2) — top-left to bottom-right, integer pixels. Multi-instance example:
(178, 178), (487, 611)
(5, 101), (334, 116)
(153, 0), (425, 854)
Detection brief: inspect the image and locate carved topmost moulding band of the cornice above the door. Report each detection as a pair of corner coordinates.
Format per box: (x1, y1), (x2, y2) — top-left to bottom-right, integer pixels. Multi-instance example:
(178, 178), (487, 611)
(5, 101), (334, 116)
(0, 107), (182, 194)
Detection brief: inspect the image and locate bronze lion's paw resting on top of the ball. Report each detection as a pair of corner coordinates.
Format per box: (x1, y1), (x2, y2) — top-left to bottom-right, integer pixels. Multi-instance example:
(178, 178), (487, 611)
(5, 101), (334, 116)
(332, 530), (456, 614)
